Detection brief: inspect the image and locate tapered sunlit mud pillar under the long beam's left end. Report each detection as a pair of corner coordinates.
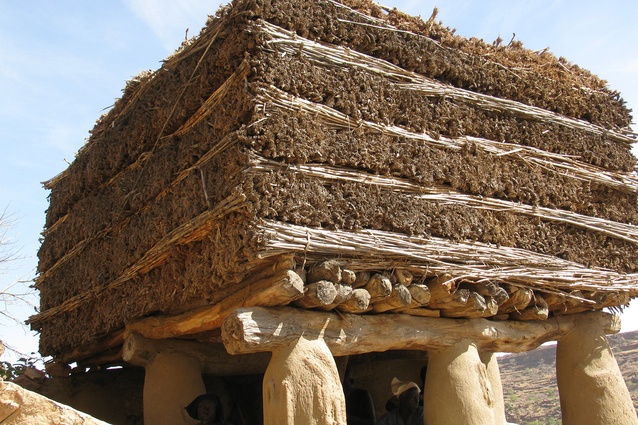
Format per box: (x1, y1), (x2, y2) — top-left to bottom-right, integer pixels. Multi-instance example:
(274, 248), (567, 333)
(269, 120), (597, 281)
(263, 336), (346, 425)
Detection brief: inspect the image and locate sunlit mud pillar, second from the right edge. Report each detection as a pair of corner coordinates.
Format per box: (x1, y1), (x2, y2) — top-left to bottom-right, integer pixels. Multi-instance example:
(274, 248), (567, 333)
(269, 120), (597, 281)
(424, 340), (503, 425)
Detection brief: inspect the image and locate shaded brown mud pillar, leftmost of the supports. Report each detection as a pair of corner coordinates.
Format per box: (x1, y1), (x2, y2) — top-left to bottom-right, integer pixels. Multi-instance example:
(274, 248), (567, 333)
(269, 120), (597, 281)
(143, 353), (206, 425)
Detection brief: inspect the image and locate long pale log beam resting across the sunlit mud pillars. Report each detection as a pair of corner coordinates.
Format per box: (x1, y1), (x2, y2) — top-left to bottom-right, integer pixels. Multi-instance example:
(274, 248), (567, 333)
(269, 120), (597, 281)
(222, 307), (620, 356)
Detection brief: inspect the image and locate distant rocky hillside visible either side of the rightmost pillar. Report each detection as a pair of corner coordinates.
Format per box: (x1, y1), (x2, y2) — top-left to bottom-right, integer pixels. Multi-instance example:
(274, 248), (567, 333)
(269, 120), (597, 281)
(499, 331), (638, 425)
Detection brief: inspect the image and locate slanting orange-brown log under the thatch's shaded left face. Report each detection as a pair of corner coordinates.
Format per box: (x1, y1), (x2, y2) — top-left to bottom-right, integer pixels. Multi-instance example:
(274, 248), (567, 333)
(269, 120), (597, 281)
(126, 270), (305, 339)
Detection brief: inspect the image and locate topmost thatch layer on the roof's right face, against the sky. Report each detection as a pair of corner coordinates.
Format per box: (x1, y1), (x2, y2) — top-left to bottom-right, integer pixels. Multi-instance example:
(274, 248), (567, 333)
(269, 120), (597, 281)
(244, 0), (631, 128)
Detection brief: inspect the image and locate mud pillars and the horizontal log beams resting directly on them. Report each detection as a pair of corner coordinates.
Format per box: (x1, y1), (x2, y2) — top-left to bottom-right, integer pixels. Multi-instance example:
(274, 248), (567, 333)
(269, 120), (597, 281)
(123, 307), (638, 425)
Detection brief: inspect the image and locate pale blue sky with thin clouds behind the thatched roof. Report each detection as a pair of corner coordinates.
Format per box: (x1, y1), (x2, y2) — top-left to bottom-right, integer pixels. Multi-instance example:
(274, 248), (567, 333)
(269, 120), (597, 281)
(0, 0), (638, 356)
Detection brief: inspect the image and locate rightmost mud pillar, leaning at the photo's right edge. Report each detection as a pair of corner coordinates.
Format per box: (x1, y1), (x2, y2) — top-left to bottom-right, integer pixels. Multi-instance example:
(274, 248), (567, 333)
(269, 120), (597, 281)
(556, 316), (638, 425)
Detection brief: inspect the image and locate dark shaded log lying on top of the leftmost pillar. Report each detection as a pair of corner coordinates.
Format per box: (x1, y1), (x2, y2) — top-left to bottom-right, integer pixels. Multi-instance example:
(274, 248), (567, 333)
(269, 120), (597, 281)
(122, 334), (270, 376)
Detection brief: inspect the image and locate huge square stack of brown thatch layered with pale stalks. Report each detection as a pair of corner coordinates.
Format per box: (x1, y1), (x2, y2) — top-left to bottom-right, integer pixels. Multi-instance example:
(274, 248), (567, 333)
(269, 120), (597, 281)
(30, 0), (638, 355)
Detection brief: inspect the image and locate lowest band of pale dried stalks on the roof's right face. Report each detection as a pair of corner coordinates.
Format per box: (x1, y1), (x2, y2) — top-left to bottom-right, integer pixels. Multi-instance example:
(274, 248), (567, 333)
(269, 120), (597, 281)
(259, 220), (638, 296)
